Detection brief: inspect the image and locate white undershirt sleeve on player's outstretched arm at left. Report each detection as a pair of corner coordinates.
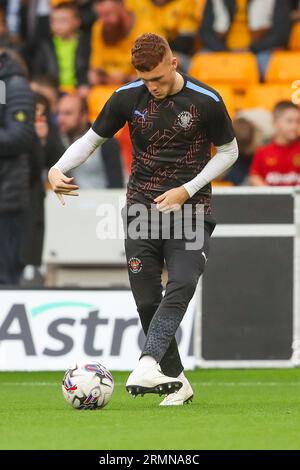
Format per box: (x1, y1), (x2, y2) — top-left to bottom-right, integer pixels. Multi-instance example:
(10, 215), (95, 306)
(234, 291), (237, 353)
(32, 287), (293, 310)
(52, 128), (107, 173)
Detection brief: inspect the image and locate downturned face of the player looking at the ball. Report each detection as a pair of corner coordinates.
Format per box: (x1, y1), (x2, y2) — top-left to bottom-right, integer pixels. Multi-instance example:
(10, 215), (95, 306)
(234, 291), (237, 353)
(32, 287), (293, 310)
(137, 55), (177, 100)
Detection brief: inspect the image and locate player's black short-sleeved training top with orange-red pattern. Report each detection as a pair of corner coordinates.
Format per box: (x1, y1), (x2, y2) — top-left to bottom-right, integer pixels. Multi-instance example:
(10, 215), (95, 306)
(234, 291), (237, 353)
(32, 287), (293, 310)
(92, 74), (234, 215)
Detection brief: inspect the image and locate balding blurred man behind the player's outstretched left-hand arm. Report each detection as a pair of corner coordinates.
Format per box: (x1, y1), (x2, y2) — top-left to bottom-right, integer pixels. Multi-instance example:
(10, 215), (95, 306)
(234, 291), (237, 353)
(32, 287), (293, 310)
(58, 95), (124, 189)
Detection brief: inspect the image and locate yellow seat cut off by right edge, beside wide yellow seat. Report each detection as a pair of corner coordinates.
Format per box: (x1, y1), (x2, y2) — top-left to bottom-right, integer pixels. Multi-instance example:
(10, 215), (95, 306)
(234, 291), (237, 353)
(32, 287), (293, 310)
(265, 51), (300, 84)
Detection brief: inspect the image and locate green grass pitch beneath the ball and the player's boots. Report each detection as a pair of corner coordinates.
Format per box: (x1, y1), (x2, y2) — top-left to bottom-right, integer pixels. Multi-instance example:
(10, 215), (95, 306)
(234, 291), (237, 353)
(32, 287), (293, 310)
(0, 369), (300, 450)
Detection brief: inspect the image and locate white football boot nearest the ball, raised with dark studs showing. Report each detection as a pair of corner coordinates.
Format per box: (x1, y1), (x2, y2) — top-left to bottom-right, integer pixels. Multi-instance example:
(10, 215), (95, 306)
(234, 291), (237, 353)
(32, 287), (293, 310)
(126, 364), (183, 397)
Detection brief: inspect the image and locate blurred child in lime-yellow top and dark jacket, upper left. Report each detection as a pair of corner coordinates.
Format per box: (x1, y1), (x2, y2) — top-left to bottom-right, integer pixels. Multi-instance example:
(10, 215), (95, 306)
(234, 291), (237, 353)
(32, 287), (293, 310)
(33, 3), (90, 94)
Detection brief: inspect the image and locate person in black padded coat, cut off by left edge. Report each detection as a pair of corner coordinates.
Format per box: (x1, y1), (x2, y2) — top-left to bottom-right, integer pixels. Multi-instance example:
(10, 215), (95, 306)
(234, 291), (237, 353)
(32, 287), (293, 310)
(0, 49), (35, 285)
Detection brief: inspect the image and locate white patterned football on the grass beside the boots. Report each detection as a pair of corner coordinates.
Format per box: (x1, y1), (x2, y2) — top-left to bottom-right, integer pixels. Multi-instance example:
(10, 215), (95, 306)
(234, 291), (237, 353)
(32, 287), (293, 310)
(62, 362), (114, 410)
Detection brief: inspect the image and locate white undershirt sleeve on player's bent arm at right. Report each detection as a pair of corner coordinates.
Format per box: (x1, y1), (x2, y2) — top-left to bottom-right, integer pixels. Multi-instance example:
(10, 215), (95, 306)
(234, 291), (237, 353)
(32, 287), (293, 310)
(183, 139), (239, 197)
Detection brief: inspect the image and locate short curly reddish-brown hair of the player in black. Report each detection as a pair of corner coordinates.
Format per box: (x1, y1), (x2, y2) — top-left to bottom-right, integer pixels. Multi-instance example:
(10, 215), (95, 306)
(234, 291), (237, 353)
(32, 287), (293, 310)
(131, 33), (170, 72)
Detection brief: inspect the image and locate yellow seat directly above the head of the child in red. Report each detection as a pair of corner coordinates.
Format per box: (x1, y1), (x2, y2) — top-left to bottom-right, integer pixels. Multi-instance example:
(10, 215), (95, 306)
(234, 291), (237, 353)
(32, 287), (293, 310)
(243, 84), (294, 111)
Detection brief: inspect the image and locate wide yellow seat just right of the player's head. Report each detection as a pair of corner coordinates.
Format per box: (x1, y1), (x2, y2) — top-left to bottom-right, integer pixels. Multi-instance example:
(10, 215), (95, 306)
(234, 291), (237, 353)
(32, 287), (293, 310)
(189, 52), (259, 88)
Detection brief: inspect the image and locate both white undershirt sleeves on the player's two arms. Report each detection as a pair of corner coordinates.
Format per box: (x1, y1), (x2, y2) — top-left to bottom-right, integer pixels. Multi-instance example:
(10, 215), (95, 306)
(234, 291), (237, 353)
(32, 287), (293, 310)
(52, 128), (239, 197)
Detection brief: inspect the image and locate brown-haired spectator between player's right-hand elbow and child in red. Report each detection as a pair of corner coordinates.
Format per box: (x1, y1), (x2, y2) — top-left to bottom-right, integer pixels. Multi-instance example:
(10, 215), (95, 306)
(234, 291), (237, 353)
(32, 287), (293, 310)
(224, 118), (256, 186)
